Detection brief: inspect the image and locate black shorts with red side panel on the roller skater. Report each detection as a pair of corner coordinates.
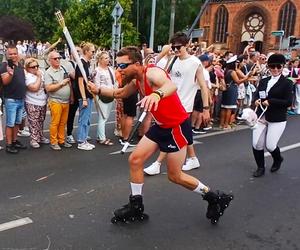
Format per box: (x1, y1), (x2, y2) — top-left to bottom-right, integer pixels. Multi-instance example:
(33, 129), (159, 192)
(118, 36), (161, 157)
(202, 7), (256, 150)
(145, 119), (193, 153)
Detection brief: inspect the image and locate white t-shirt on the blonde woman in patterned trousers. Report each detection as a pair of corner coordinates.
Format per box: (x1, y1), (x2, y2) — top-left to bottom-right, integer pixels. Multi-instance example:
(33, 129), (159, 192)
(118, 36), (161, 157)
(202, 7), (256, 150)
(25, 72), (48, 106)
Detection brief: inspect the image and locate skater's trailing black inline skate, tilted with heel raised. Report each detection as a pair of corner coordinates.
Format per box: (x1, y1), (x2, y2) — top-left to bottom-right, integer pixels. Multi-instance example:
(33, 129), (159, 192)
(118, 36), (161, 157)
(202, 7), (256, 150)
(203, 191), (233, 224)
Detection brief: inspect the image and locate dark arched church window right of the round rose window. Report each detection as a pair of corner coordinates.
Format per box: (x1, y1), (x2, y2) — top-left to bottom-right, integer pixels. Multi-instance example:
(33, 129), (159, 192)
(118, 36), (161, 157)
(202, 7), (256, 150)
(278, 1), (296, 37)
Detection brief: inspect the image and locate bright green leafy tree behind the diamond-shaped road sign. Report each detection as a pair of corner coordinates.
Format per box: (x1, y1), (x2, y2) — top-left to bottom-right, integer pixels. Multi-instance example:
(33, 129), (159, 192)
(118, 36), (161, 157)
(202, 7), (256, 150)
(65, 0), (137, 47)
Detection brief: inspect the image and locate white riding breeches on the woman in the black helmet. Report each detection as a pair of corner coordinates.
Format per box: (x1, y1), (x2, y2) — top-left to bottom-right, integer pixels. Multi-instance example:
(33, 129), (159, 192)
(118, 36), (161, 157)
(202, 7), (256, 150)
(252, 117), (286, 152)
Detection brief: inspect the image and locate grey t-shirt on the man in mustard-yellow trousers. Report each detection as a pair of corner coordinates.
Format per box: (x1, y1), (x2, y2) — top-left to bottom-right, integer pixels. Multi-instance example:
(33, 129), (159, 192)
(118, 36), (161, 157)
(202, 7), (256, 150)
(45, 67), (71, 103)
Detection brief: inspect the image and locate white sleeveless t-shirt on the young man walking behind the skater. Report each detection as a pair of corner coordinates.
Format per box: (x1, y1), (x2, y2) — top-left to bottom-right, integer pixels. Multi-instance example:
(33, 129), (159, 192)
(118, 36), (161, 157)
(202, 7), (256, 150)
(170, 56), (201, 113)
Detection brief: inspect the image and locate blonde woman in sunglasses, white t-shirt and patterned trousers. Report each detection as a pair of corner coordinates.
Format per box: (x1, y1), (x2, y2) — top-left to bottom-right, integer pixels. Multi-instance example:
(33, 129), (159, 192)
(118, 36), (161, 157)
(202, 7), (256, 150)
(25, 58), (49, 148)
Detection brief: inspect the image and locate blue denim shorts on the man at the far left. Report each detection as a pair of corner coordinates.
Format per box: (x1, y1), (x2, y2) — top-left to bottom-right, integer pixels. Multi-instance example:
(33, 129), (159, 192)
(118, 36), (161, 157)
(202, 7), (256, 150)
(5, 98), (24, 128)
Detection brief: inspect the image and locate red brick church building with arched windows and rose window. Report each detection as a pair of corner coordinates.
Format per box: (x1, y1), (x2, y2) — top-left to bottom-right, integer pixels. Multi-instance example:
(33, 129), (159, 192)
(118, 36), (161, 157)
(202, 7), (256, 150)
(200, 0), (300, 53)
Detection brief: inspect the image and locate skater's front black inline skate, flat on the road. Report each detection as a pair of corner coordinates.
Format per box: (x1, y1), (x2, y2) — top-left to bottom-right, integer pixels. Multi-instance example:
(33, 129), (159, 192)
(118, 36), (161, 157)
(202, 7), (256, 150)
(111, 195), (149, 223)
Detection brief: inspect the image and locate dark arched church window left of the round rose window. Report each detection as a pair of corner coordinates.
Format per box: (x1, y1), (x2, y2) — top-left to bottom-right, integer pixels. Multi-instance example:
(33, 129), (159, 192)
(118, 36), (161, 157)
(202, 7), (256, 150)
(214, 6), (228, 43)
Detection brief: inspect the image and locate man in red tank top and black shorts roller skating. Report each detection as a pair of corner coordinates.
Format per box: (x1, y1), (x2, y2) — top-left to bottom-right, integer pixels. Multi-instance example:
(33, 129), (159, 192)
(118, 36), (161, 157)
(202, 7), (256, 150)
(89, 47), (233, 224)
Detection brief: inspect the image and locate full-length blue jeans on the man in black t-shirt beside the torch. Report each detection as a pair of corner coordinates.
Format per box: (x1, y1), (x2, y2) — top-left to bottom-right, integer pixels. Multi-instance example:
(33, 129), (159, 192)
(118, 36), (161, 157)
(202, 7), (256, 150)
(77, 98), (93, 143)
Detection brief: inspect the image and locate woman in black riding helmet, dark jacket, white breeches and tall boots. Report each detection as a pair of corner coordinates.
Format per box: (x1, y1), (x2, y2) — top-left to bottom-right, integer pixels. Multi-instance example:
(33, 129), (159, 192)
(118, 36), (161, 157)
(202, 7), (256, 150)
(252, 54), (293, 177)
